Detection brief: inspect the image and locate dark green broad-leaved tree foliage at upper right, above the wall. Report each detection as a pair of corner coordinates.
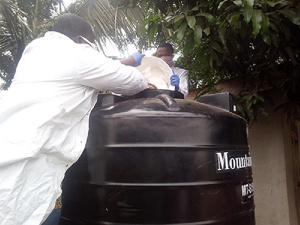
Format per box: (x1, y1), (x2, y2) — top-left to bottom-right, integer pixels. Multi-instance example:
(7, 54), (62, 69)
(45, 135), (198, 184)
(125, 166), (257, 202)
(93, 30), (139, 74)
(141, 0), (300, 121)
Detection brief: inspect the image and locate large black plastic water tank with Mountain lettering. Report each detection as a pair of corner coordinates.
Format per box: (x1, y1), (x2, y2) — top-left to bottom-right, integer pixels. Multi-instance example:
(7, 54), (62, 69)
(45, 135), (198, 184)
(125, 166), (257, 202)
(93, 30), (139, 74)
(60, 91), (255, 225)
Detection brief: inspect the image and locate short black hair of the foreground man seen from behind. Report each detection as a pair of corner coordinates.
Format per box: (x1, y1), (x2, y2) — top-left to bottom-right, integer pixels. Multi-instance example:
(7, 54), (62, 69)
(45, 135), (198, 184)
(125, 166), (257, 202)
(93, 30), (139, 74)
(52, 13), (93, 40)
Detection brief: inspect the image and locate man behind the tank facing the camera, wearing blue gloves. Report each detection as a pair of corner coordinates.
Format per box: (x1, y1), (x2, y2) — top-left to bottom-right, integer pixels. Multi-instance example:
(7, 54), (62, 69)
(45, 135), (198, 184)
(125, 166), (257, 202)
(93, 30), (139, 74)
(156, 43), (189, 97)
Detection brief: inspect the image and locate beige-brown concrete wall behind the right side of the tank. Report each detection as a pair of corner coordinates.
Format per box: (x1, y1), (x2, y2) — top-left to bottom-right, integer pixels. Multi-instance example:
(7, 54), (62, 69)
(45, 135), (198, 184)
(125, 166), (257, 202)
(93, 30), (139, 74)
(187, 88), (300, 225)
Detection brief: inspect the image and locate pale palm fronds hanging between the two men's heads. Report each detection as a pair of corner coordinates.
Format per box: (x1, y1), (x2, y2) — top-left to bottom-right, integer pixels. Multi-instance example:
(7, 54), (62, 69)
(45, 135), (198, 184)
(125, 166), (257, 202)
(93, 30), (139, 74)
(68, 0), (148, 53)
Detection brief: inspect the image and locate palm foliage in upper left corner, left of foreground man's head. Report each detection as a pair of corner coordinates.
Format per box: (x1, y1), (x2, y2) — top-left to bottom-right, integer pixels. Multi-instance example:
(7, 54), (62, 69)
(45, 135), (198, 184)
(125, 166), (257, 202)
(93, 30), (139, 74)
(0, 0), (60, 89)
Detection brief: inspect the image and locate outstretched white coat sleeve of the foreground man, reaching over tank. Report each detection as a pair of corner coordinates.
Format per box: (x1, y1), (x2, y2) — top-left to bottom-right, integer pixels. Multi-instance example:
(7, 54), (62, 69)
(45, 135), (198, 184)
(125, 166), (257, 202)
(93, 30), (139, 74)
(77, 46), (148, 95)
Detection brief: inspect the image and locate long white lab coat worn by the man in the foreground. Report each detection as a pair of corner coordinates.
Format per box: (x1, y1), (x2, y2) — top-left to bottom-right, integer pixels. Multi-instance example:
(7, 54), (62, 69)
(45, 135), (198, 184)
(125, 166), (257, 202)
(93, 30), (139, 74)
(0, 32), (147, 225)
